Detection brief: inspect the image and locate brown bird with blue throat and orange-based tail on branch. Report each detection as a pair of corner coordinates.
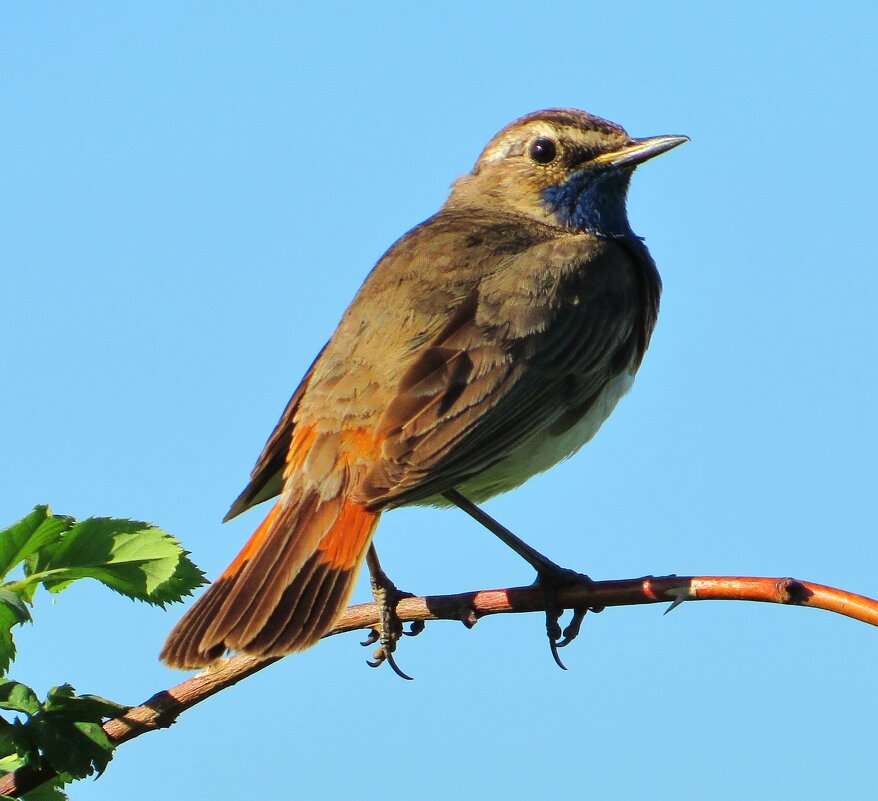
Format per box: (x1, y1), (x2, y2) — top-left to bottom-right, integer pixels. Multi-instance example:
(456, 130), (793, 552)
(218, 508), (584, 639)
(161, 108), (688, 678)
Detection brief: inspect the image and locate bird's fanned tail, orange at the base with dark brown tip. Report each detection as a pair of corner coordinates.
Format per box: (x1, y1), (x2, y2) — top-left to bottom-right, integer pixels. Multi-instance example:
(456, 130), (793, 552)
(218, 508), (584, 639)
(161, 491), (380, 669)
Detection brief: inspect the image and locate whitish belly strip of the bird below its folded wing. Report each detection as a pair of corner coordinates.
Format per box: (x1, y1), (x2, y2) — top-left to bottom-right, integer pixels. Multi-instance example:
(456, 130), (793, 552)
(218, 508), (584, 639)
(457, 371), (634, 503)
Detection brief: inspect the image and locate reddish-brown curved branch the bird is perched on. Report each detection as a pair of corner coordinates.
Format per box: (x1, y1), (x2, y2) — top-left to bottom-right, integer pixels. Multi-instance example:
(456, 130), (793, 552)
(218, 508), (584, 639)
(0, 576), (878, 796)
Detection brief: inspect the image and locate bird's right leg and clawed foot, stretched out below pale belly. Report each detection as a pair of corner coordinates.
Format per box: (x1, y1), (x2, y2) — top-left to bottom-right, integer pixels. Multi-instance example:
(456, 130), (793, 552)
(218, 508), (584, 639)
(443, 489), (600, 670)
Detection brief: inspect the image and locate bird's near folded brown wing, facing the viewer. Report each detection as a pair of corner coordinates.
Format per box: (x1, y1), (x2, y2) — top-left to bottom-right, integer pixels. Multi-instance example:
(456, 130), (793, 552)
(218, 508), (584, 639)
(359, 231), (642, 508)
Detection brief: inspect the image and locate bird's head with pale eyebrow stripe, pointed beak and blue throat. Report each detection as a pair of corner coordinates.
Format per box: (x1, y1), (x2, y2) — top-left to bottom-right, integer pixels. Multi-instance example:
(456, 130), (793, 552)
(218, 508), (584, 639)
(446, 109), (688, 237)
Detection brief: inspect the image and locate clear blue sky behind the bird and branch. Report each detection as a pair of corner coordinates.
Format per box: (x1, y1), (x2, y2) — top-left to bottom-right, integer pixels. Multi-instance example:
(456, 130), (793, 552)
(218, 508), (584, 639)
(0, 0), (878, 801)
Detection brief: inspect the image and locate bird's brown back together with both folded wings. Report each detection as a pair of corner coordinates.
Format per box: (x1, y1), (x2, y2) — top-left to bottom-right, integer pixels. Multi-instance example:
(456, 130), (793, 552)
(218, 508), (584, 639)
(226, 212), (637, 519)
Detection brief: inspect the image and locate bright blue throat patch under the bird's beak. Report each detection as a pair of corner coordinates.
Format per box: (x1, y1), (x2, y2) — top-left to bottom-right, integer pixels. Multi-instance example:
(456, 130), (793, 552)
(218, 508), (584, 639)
(543, 169), (634, 234)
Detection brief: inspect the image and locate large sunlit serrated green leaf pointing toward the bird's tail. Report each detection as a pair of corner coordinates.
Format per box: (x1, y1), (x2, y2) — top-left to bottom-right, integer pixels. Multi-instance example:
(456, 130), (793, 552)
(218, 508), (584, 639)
(31, 517), (205, 605)
